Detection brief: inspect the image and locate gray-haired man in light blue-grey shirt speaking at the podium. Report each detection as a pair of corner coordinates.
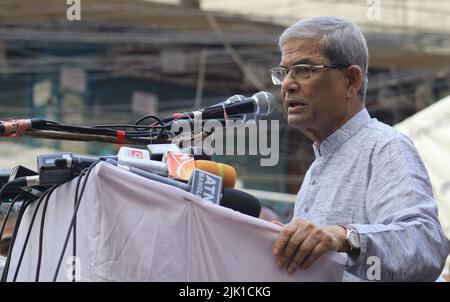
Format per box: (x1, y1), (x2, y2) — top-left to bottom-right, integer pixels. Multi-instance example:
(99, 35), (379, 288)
(271, 17), (450, 281)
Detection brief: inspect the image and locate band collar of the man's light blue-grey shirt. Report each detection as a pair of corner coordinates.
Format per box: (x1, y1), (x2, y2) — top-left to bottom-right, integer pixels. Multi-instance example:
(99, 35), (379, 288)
(313, 108), (370, 158)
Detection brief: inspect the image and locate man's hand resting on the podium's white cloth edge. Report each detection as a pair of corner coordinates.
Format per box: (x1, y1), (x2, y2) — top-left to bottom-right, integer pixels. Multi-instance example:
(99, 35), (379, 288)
(273, 218), (349, 273)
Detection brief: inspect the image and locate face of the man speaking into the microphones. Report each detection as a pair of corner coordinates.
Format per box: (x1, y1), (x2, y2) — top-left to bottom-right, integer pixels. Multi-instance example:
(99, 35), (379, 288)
(280, 40), (348, 139)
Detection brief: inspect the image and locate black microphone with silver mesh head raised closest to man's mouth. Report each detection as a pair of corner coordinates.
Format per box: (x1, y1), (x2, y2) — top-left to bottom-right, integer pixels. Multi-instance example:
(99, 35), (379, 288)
(163, 91), (276, 123)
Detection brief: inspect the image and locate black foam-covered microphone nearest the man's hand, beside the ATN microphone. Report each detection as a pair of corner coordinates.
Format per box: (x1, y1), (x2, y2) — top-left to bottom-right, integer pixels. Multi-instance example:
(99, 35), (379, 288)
(220, 188), (261, 217)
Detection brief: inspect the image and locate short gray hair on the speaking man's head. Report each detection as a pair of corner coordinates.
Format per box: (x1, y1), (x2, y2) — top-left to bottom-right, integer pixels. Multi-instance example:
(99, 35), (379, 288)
(279, 17), (369, 102)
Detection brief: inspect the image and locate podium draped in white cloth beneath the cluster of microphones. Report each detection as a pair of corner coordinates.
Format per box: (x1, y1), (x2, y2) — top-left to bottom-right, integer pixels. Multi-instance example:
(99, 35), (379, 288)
(8, 163), (346, 282)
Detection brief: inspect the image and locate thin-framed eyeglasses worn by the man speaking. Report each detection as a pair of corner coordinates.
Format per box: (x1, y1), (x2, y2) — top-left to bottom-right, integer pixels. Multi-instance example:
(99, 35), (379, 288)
(270, 64), (350, 85)
